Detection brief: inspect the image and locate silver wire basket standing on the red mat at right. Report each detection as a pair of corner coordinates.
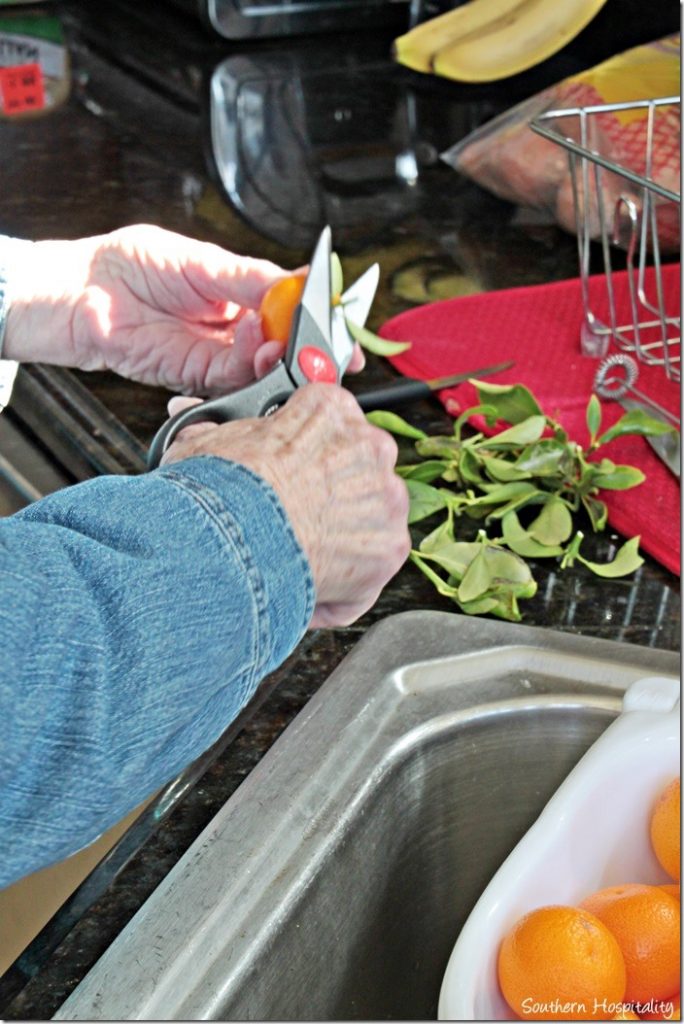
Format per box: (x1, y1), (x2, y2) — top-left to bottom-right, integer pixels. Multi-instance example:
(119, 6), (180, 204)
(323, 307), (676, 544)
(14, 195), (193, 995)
(530, 96), (681, 393)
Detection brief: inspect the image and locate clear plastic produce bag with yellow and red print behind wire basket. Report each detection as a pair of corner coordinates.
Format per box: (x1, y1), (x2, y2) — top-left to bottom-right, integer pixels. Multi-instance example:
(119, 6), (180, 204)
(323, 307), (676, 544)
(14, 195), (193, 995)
(442, 35), (680, 251)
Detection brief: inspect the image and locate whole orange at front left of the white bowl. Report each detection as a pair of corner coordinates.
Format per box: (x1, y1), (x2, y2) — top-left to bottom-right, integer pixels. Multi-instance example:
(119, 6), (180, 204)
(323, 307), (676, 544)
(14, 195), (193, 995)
(498, 906), (626, 1021)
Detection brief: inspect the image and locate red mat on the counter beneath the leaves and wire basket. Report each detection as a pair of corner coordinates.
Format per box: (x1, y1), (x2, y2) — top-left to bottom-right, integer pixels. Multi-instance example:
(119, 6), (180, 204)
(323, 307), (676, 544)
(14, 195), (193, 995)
(380, 264), (681, 573)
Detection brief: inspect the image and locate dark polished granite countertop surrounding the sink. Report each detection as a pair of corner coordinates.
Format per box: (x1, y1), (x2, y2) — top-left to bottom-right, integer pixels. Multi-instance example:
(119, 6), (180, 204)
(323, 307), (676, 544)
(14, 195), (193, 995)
(0, 0), (680, 1019)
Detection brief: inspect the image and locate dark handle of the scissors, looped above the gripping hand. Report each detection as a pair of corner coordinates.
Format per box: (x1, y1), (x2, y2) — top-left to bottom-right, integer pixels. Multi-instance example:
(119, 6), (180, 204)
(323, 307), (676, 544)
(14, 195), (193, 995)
(147, 360), (297, 469)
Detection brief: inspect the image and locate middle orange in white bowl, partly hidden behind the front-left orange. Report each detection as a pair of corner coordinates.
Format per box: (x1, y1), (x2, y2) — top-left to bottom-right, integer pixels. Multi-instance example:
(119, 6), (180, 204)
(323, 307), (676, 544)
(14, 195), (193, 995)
(580, 884), (680, 1012)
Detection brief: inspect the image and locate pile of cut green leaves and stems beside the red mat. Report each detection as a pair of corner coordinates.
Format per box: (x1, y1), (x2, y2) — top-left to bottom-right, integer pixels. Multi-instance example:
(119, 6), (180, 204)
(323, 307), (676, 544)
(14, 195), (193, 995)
(368, 381), (672, 622)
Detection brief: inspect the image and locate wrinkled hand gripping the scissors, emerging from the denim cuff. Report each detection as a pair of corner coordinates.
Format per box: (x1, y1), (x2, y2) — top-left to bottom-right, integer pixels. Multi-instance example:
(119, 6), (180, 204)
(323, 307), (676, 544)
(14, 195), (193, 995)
(163, 384), (411, 627)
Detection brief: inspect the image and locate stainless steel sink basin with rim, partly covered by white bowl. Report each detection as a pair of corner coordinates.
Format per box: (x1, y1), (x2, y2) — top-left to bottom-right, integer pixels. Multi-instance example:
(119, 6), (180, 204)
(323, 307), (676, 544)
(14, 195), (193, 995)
(56, 612), (678, 1020)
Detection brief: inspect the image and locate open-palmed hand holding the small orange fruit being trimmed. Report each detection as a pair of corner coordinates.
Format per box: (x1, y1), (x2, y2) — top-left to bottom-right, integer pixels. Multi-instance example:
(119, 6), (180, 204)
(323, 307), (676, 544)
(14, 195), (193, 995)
(4, 224), (364, 395)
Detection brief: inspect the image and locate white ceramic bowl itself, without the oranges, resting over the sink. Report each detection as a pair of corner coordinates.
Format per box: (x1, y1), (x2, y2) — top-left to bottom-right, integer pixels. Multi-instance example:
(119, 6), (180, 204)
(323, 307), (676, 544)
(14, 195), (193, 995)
(438, 677), (680, 1021)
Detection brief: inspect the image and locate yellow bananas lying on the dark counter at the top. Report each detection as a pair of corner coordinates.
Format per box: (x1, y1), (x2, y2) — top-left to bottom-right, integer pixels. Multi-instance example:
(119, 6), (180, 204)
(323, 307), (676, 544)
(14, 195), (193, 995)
(394, 0), (606, 82)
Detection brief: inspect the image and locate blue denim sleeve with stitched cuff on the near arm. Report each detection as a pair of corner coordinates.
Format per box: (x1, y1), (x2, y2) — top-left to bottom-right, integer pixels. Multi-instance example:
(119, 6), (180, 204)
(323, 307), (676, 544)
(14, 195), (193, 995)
(0, 457), (314, 887)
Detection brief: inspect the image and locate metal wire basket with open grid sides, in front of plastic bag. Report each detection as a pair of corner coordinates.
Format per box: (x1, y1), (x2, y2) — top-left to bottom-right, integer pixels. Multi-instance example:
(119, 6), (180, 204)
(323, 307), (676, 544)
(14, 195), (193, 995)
(530, 96), (681, 381)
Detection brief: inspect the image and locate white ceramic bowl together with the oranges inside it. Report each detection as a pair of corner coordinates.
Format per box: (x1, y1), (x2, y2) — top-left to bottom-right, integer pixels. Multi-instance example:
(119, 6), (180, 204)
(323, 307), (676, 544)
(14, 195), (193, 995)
(439, 677), (680, 1021)
